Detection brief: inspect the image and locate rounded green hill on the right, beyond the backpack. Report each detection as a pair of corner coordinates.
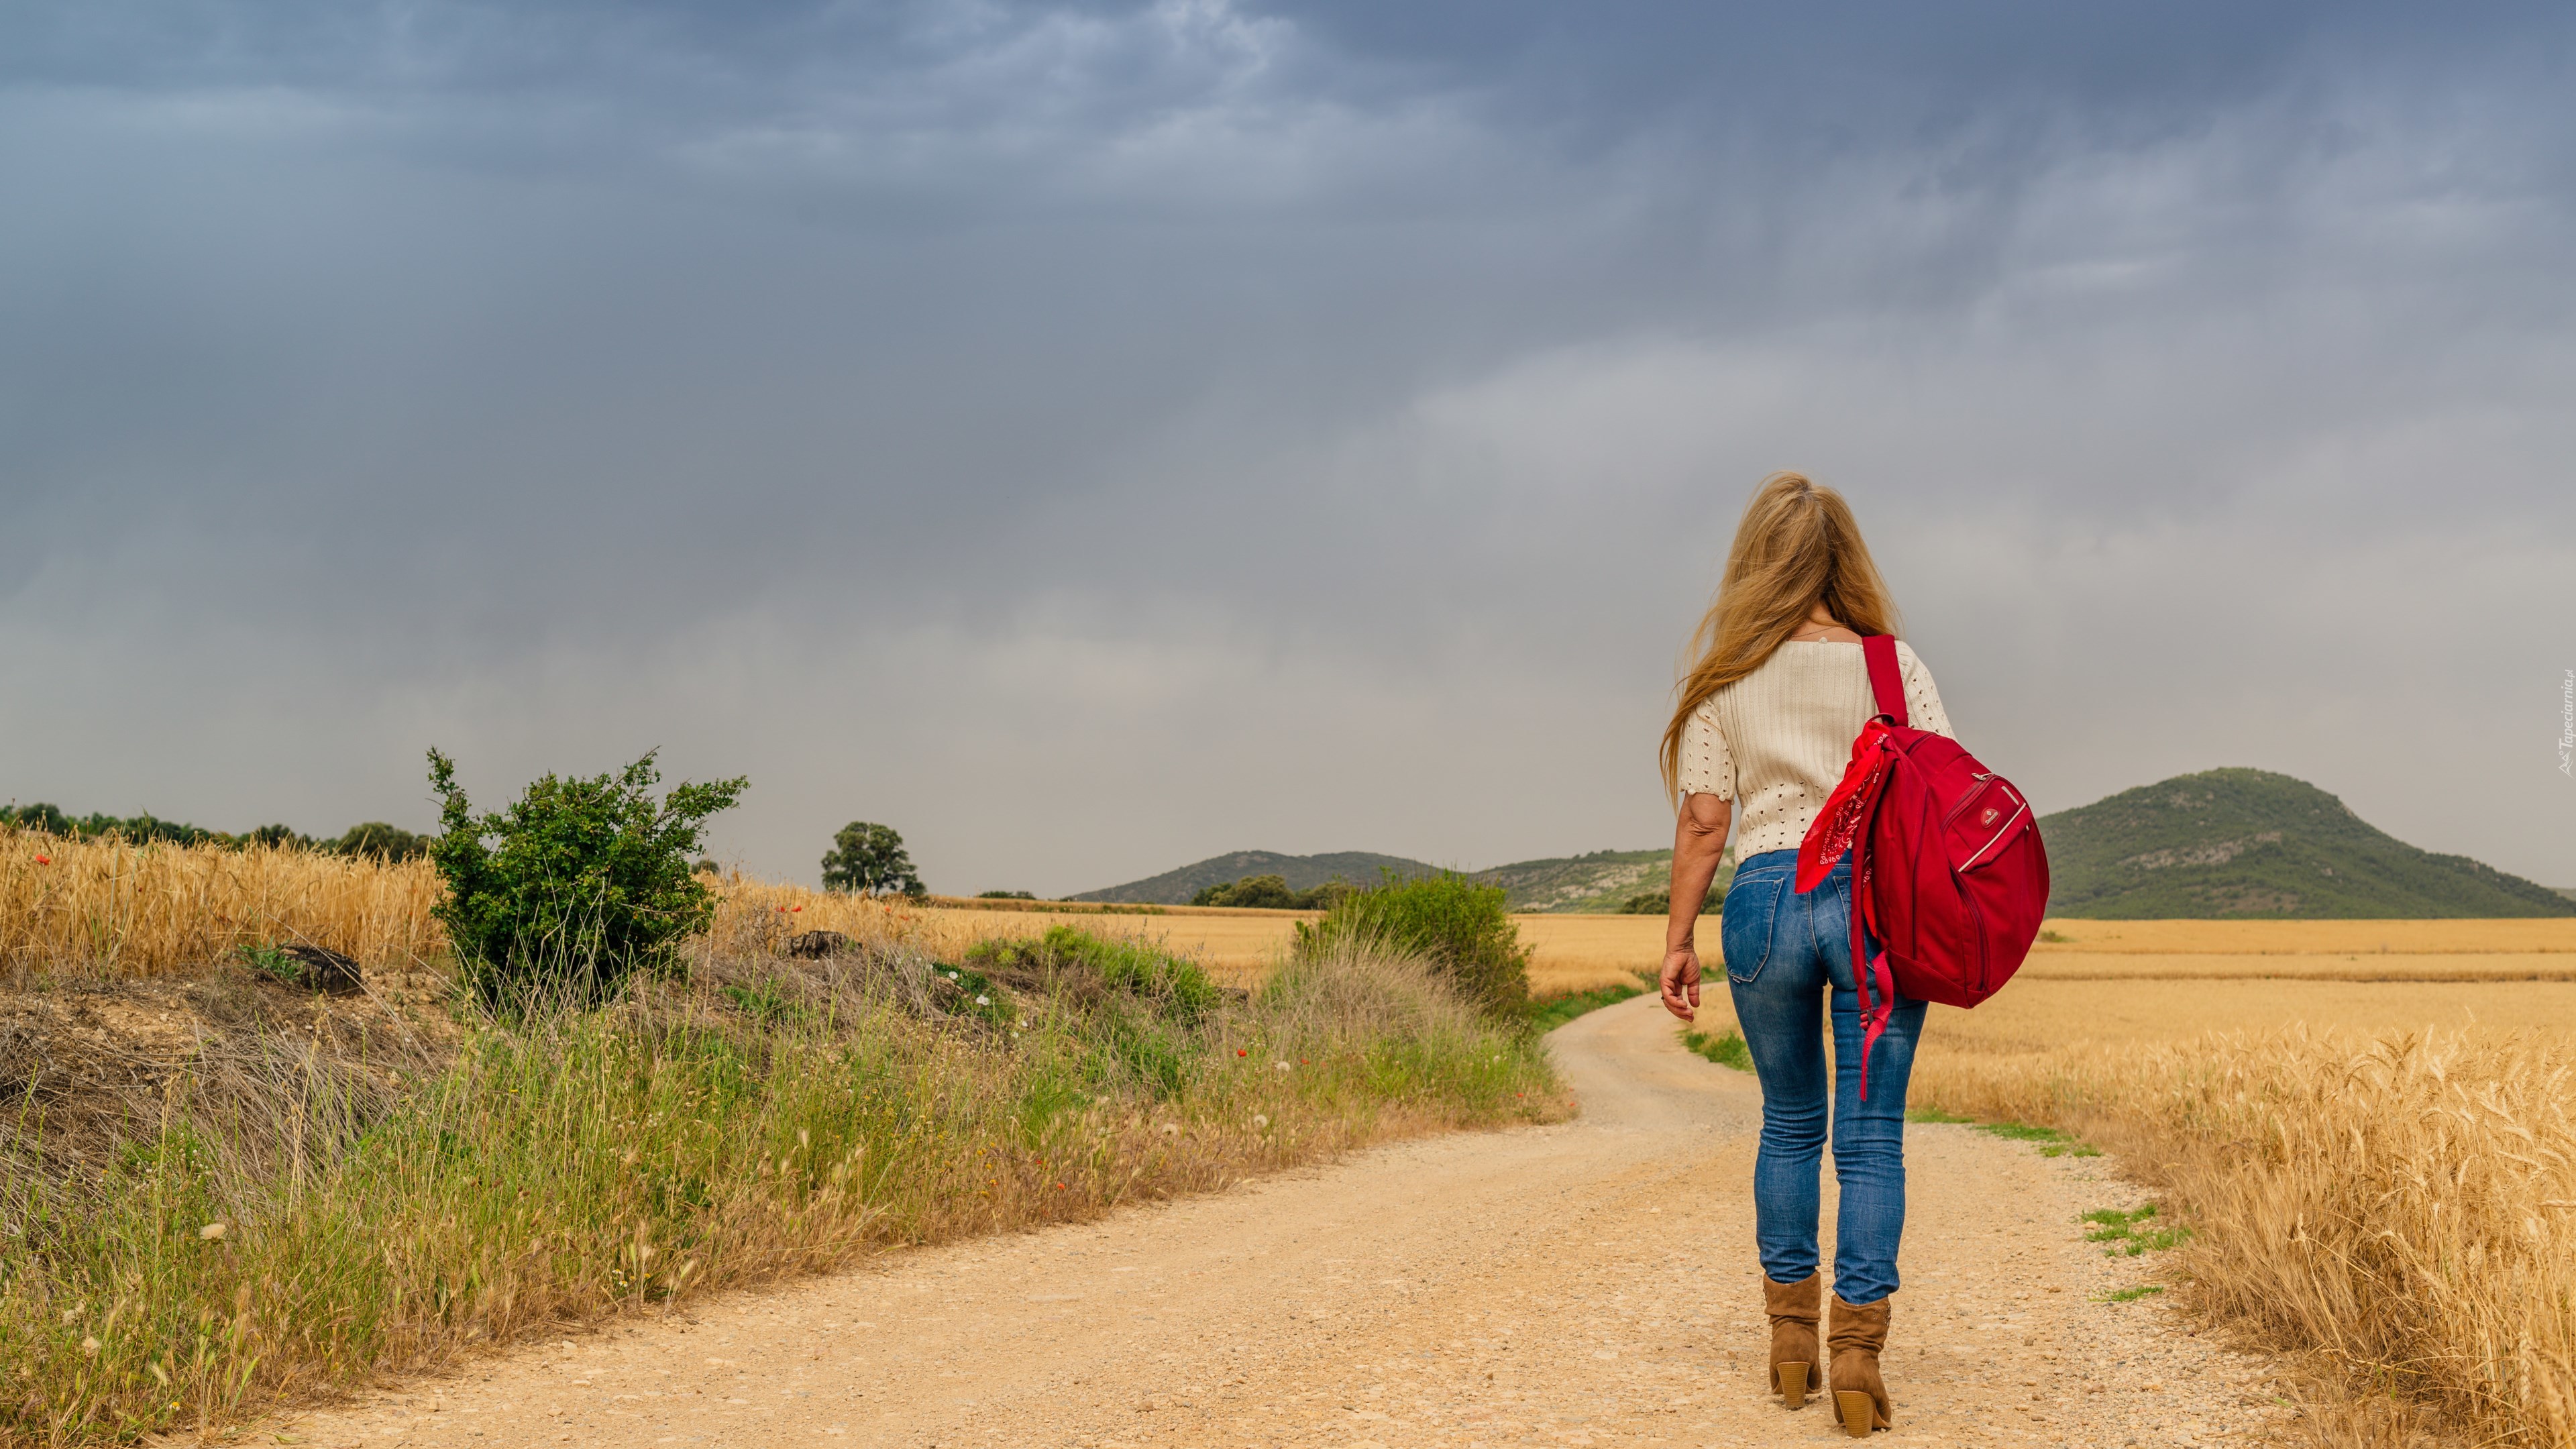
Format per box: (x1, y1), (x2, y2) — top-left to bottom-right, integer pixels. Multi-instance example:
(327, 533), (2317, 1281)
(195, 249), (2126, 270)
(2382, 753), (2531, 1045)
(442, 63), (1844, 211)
(2040, 768), (2576, 920)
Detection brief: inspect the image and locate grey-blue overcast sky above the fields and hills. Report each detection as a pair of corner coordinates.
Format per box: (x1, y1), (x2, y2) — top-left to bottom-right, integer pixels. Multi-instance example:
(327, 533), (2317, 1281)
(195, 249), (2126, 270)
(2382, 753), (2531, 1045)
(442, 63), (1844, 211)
(0, 0), (2576, 895)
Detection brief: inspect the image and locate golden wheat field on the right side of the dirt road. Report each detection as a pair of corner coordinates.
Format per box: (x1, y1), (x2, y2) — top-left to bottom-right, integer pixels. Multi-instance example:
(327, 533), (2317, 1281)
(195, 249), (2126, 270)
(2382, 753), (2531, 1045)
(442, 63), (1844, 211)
(1669, 920), (2576, 1449)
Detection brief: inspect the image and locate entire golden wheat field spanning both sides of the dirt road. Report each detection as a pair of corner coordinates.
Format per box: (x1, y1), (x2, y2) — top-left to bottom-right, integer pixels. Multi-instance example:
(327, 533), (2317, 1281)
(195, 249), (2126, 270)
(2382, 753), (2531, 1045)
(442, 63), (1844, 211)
(0, 833), (2576, 1449)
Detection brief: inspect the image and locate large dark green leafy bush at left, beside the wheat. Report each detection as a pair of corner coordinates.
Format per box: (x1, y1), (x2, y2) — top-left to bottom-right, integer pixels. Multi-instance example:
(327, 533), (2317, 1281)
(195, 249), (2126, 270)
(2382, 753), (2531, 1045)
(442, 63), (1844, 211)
(430, 750), (749, 1008)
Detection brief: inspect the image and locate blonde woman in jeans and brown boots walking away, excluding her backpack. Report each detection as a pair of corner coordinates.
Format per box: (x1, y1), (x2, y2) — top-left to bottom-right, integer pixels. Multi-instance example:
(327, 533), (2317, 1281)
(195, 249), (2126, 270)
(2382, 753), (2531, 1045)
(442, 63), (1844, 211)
(1664, 472), (1950, 1436)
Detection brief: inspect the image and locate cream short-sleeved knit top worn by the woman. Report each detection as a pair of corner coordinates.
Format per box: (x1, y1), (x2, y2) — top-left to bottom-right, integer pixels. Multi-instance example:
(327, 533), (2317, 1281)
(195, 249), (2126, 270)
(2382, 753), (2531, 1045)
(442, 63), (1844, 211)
(1682, 639), (1950, 861)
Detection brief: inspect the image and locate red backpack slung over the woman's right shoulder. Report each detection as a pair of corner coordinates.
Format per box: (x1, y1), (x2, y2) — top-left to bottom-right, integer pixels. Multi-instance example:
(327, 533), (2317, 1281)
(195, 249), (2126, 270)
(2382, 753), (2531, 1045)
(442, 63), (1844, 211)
(1798, 634), (2048, 1101)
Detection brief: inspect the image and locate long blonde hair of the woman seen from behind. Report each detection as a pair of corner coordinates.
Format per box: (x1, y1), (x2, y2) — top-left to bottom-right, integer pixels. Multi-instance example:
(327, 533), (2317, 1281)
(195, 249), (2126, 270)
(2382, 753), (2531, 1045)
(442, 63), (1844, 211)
(1664, 472), (1896, 802)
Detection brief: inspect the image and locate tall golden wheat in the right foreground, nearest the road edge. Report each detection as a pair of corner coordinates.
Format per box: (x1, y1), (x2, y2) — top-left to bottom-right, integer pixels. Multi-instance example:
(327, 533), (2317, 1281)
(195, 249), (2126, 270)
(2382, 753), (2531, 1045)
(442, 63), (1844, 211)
(1914, 1020), (2576, 1449)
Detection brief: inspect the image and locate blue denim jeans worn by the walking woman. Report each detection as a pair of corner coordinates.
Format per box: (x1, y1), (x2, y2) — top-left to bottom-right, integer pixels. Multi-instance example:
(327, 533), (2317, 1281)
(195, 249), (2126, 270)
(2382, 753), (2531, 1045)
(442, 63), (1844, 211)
(1718, 835), (1924, 1302)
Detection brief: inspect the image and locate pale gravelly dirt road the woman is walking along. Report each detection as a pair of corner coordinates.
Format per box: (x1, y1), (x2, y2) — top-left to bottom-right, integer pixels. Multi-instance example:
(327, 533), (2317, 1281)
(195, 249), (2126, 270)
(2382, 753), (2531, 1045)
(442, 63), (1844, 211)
(281, 998), (2282, 1449)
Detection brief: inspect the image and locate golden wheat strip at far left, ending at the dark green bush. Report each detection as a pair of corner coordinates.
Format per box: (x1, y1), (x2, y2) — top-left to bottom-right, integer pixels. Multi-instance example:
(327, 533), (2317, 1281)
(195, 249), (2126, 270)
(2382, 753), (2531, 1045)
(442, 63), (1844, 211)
(0, 830), (443, 977)
